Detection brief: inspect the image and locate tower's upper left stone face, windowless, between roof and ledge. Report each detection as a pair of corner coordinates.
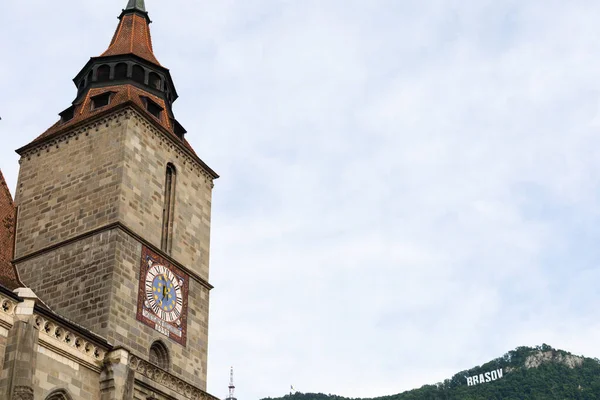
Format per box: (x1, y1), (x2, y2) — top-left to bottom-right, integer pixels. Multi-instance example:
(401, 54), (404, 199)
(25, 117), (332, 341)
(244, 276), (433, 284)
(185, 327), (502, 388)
(15, 111), (126, 258)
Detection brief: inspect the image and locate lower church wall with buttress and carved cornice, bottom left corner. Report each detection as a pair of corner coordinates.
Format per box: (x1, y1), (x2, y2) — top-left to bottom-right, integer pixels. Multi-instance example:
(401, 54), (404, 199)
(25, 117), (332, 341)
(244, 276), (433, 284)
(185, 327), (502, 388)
(0, 288), (108, 400)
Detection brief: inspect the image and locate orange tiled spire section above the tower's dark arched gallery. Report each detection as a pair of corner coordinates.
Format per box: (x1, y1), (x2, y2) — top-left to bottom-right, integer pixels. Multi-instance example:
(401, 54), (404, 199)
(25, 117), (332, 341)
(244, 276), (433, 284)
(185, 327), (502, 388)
(102, 13), (160, 65)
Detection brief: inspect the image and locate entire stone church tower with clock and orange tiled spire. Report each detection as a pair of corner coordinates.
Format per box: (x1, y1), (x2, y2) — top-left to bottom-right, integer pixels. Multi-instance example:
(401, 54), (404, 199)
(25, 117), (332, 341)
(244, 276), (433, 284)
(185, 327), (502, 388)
(13, 0), (218, 399)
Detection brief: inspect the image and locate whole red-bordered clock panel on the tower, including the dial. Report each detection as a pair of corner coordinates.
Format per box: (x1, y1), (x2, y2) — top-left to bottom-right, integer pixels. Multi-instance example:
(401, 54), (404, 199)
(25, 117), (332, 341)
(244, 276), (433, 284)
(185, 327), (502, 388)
(137, 246), (189, 346)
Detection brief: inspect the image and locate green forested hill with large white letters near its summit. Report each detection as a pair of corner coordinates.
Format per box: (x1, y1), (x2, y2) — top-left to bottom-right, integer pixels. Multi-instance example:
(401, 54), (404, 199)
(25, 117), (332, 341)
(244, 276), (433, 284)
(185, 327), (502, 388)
(264, 344), (600, 400)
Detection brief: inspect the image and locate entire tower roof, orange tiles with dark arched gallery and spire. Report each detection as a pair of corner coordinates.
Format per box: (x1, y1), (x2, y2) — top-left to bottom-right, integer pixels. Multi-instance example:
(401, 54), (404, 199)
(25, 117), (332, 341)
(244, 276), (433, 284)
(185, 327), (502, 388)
(17, 0), (218, 178)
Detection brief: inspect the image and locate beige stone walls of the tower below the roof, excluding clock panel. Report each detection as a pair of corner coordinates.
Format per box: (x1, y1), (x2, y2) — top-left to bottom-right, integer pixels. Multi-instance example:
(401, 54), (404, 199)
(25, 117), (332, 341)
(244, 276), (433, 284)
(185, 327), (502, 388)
(15, 104), (212, 390)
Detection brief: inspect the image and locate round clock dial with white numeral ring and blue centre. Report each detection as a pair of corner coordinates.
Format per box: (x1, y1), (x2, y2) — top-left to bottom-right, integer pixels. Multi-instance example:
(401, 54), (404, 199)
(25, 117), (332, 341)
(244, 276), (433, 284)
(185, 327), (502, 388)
(145, 264), (183, 322)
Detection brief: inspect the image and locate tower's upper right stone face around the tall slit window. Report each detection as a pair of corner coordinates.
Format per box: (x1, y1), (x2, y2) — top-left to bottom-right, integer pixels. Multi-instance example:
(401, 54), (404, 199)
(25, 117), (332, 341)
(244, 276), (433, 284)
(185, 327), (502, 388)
(119, 113), (213, 281)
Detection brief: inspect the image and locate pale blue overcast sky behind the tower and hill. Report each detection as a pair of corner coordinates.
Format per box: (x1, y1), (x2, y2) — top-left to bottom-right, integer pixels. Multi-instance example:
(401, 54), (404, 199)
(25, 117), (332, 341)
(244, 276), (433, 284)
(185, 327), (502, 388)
(0, 0), (600, 400)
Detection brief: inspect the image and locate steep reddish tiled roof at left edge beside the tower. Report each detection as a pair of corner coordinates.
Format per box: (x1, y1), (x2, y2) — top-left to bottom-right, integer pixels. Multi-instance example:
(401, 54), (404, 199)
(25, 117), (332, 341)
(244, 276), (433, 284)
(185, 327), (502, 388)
(0, 171), (23, 290)
